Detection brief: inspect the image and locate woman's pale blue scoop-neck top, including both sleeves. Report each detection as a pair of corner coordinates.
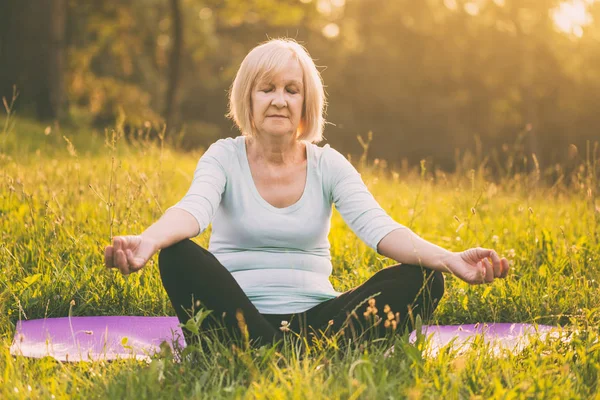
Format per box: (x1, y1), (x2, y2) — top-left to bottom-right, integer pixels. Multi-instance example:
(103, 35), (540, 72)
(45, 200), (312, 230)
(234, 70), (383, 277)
(173, 136), (403, 314)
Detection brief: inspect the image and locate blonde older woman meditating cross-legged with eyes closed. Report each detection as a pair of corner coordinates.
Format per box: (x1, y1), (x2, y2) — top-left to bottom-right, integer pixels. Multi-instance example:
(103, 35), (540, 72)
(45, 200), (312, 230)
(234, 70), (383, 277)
(105, 39), (508, 342)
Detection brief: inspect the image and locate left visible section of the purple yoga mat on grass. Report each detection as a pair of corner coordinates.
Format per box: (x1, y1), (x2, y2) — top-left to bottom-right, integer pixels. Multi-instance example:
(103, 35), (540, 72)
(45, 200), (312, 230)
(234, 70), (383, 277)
(10, 316), (185, 361)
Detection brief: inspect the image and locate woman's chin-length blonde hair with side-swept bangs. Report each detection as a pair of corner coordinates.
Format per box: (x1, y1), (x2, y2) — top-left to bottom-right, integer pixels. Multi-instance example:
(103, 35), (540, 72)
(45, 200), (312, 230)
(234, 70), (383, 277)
(227, 38), (326, 143)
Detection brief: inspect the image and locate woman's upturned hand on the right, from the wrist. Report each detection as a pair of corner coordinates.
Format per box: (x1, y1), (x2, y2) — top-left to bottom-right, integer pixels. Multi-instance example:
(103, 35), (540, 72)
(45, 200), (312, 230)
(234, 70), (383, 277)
(444, 247), (509, 285)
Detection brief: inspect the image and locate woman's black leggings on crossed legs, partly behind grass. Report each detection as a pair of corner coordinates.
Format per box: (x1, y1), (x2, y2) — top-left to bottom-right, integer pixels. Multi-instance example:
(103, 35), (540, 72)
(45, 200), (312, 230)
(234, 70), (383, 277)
(158, 239), (444, 344)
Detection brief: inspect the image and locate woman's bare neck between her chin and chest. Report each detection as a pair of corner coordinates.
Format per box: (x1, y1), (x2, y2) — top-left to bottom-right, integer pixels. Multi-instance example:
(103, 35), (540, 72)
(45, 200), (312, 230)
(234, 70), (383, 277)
(246, 135), (303, 165)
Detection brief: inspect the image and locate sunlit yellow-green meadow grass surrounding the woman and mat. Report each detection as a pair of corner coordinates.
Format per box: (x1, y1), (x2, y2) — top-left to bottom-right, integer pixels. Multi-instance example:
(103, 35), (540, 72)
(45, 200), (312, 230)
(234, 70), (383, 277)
(0, 114), (600, 399)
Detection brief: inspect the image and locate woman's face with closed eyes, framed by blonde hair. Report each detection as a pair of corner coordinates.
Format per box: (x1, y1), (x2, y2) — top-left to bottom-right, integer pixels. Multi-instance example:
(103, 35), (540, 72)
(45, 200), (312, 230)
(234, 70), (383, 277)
(252, 59), (304, 141)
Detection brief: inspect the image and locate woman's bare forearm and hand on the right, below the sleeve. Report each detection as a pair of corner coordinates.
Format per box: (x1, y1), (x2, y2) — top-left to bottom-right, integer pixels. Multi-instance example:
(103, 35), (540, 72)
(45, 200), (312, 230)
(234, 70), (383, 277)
(377, 228), (509, 284)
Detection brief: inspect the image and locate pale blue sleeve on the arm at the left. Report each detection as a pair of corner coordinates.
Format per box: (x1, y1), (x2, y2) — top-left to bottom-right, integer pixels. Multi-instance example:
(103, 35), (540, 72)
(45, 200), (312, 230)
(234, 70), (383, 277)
(169, 140), (230, 235)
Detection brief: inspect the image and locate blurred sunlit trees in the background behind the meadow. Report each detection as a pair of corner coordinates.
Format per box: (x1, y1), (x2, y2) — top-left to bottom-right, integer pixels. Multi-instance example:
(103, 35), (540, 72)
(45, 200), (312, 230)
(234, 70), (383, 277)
(0, 0), (600, 170)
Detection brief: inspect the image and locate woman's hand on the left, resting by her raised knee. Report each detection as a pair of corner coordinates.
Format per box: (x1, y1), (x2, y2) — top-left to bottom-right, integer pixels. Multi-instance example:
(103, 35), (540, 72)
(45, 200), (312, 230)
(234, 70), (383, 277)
(104, 235), (159, 275)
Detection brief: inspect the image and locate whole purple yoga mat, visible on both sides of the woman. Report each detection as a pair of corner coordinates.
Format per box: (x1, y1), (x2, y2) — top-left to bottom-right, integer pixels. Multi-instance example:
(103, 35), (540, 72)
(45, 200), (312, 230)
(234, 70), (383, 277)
(10, 316), (554, 361)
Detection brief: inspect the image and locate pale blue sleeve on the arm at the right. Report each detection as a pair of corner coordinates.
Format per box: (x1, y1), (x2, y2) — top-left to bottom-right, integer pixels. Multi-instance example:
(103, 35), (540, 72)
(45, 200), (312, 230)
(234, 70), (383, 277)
(328, 148), (404, 251)
